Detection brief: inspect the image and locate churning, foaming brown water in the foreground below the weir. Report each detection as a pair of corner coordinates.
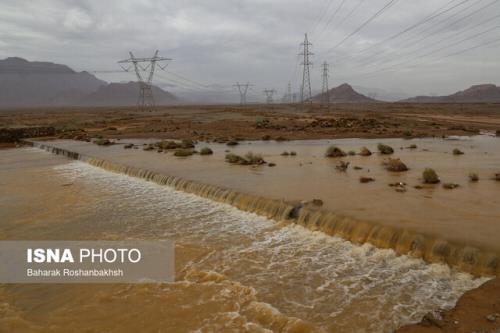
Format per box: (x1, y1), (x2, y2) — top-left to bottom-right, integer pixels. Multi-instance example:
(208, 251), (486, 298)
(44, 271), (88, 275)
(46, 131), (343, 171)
(0, 148), (485, 332)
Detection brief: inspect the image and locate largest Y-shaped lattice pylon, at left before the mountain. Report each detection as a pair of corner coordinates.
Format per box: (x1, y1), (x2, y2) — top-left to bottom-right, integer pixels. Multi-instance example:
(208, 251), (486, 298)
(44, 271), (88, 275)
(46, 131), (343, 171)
(118, 50), (172, 111)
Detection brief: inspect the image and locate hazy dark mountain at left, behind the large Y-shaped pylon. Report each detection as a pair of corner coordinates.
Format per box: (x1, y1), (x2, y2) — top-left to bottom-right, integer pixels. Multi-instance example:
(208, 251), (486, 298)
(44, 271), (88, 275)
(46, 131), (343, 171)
(0, 57), (177, 107)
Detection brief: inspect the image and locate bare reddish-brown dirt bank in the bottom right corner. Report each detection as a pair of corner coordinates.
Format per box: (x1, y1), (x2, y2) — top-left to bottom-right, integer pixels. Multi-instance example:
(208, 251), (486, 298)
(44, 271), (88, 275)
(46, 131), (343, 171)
(397, 278), (500, 333)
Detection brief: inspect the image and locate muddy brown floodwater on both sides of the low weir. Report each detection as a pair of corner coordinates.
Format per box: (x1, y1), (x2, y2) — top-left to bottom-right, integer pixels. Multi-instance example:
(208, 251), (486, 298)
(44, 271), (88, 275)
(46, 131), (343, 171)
(0, 143), (492, 332)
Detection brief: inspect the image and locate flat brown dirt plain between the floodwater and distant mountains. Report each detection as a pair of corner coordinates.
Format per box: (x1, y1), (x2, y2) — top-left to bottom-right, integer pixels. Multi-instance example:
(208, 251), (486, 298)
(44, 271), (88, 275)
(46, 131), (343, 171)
(0, 103), (500, 141)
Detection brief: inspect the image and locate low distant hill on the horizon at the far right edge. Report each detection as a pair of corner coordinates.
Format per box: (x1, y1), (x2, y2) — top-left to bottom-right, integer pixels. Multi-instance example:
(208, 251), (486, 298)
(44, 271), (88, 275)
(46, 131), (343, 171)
(400, 84), (500, 103)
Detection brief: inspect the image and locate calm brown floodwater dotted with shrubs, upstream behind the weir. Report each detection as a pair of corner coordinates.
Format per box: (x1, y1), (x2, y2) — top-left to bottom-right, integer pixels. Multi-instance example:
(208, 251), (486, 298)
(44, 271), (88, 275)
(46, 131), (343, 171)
(31, 135), (500, 252)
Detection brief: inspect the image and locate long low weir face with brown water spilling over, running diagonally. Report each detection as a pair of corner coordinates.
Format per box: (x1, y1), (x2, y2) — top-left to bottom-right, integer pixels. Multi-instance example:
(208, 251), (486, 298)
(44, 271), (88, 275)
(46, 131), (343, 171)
(25, 141), (500, 276)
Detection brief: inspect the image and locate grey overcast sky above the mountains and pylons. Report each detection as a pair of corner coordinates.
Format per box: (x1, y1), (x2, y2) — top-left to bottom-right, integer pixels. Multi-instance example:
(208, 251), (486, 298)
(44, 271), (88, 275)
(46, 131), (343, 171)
(0, 0), (500, 95)
